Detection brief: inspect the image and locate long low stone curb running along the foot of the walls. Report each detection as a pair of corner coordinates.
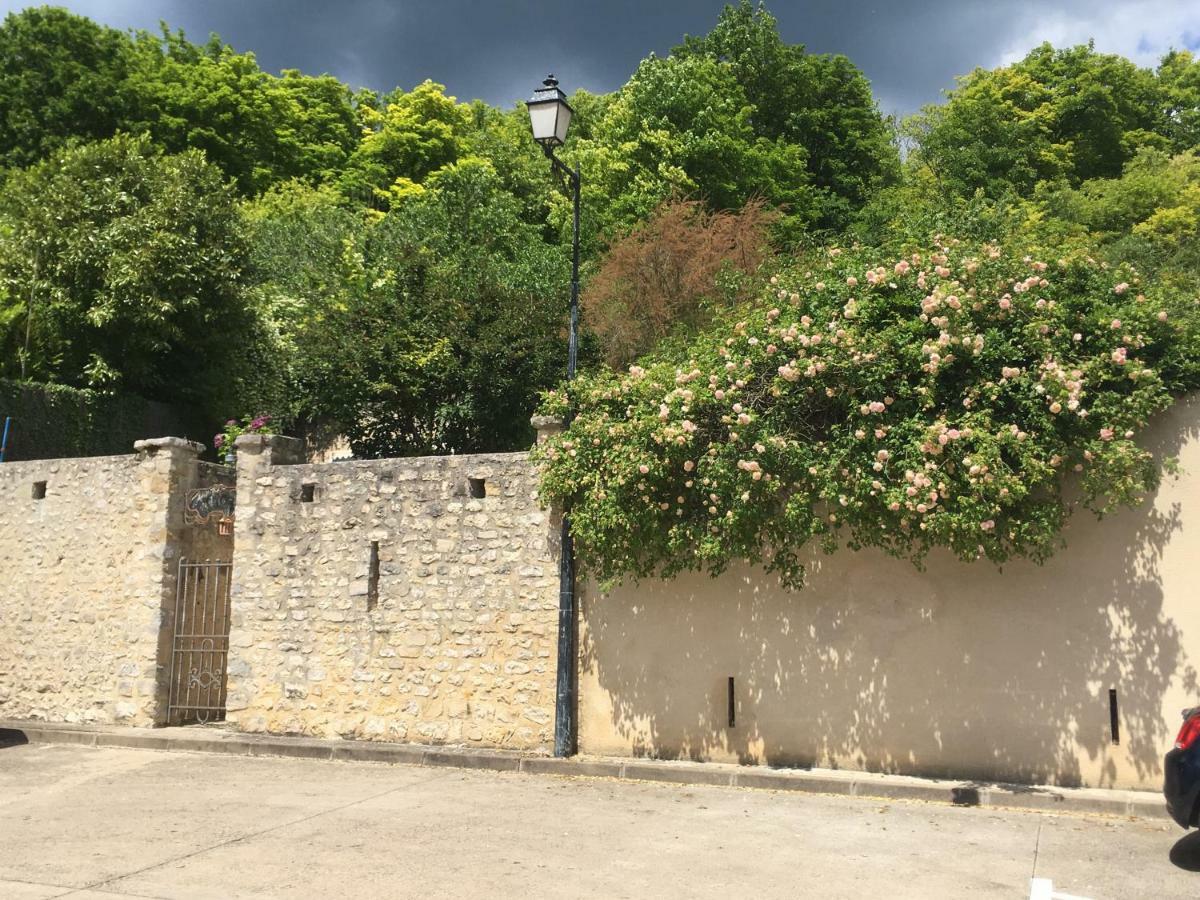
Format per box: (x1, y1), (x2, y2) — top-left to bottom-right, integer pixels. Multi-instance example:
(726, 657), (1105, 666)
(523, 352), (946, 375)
(0, 721), (1168, 820)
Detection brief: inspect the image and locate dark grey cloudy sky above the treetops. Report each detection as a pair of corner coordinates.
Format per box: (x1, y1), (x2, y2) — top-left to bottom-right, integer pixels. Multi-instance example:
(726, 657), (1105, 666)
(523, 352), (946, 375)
(0, 0), (1200, 113)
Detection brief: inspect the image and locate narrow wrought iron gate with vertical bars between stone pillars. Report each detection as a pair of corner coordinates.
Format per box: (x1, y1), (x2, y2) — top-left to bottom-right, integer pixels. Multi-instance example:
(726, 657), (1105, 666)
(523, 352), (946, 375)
(167, 559), (233, 725)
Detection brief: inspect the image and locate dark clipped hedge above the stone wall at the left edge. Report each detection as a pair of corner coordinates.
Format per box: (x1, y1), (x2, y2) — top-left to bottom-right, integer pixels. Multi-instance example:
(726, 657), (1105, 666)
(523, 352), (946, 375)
(0, 379), (209, 461)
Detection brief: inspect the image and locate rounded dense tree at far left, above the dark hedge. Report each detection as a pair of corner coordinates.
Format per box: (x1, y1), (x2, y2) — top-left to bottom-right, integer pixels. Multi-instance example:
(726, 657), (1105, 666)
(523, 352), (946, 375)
(0, 136), (261, 415)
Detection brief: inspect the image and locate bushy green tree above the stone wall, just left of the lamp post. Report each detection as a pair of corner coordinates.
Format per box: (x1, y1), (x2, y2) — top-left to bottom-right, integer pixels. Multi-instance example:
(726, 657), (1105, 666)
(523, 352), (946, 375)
(283, 158), (578, 456)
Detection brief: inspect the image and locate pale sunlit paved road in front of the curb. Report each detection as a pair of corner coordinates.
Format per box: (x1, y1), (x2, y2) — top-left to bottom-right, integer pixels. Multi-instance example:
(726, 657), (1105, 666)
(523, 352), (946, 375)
(0, 744), (1200, 900)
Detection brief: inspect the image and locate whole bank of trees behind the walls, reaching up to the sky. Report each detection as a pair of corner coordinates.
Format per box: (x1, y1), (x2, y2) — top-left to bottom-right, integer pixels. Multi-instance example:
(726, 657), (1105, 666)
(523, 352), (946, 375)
(9, 0), (1200, 487)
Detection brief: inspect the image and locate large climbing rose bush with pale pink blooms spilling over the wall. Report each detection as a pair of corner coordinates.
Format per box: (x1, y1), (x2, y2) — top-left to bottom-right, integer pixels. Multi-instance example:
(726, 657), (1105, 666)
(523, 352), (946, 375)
(535, 239), (1200, 587)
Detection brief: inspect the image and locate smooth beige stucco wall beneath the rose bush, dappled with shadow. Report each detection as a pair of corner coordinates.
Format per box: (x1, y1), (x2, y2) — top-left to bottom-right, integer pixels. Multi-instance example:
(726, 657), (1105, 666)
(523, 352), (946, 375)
(580, 398), (1200, 788)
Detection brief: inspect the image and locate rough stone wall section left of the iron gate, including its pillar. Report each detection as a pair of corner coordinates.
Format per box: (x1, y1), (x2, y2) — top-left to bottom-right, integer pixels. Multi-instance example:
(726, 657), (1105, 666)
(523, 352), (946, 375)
(0, 438), (229, 725)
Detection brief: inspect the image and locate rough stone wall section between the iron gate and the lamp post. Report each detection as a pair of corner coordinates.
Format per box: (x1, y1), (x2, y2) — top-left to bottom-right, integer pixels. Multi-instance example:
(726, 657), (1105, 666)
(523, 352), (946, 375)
(227, 436), (558, 749)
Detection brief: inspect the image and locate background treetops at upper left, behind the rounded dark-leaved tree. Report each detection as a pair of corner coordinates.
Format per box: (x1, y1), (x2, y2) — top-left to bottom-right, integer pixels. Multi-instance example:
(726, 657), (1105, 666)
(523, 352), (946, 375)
(0, 7), (359, 194)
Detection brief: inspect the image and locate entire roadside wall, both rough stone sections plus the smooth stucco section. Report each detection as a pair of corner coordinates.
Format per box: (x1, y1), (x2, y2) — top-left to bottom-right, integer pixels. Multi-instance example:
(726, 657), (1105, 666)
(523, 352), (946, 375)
(0, 412), (1200, 788)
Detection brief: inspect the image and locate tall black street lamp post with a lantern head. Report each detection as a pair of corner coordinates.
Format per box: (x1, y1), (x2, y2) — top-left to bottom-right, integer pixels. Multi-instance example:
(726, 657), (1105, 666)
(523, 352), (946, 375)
(526, 76), (580, 756)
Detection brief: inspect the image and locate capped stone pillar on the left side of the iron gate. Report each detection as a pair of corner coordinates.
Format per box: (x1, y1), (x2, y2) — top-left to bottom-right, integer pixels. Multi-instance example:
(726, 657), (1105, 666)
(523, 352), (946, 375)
(133, 438), (204, 725)
